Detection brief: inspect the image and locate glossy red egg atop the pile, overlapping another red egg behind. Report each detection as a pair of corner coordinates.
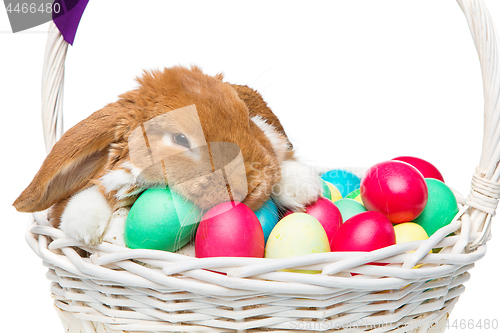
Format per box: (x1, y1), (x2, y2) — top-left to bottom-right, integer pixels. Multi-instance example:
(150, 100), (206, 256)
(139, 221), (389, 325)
(361, 161), (427, 223)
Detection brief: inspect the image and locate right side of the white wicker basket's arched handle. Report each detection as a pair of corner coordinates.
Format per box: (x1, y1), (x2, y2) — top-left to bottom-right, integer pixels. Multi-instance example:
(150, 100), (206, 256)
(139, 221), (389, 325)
(457, 0), (500, 249)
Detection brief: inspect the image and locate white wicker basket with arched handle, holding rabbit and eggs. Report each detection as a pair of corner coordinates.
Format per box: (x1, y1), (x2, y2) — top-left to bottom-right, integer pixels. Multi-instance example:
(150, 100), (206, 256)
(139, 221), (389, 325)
(27, 0), (500, 333)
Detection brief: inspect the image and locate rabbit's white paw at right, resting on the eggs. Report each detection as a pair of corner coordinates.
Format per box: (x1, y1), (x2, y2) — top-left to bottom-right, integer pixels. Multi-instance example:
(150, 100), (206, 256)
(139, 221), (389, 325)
(272, 161), (322, 212)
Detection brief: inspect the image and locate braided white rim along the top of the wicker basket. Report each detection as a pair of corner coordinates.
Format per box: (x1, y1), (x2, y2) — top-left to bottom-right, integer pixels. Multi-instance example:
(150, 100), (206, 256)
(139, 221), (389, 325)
(26, 198), (486, 292)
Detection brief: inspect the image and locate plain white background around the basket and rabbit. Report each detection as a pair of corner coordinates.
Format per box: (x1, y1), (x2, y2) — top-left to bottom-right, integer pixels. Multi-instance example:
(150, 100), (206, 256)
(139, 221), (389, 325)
(0, 0), (500, 333)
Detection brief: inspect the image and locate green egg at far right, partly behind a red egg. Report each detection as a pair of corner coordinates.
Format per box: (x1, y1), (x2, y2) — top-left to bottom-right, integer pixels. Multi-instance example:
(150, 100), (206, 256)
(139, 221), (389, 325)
(413, 178), (458, 237)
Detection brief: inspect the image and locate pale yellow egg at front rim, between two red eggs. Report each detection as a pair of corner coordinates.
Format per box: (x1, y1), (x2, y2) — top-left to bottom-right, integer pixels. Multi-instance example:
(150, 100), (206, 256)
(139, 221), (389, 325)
(265, 213), (330, 258)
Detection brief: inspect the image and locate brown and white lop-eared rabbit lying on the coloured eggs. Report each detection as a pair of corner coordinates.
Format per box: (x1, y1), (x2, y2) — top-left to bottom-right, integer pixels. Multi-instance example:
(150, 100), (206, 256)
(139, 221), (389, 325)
(14, 66), (321, 244)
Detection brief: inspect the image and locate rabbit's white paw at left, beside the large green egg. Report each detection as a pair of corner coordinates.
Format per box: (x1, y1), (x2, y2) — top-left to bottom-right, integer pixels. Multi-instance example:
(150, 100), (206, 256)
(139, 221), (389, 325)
(60, 186), (113, 245)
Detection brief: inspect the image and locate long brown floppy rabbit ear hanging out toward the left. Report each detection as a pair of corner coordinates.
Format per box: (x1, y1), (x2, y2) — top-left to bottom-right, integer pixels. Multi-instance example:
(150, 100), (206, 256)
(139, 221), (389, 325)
(14, 103), (128, 212)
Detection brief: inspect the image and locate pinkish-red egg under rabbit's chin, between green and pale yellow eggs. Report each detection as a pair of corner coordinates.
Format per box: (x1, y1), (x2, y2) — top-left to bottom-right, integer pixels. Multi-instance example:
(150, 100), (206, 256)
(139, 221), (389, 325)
(195, 201), (264, 258)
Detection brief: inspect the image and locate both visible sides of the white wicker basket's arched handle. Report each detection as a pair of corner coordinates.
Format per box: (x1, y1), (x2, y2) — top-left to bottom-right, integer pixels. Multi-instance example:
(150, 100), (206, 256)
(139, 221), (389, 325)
(42, 0), (500, 246)
